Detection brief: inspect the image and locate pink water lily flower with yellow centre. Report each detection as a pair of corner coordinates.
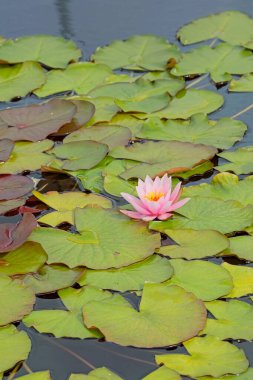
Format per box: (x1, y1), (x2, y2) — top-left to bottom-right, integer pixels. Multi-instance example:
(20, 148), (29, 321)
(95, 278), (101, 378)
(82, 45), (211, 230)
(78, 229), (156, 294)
(120, 174), (190, 222)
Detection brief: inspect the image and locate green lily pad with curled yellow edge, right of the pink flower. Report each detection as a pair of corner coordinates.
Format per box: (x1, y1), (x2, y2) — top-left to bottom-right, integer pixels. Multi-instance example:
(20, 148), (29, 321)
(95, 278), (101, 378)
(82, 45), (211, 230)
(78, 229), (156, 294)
(183, 172), (253, 206)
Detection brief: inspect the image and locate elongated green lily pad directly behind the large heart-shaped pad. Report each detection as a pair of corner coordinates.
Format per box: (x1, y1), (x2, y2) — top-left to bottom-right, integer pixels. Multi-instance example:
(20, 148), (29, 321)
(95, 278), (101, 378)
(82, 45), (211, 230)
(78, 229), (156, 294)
(78, 255), (173, 292)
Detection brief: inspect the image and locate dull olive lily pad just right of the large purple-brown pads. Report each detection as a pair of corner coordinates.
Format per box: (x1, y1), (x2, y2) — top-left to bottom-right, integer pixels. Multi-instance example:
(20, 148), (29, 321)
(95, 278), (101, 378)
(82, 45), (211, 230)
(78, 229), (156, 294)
(64, 125), (132, 149)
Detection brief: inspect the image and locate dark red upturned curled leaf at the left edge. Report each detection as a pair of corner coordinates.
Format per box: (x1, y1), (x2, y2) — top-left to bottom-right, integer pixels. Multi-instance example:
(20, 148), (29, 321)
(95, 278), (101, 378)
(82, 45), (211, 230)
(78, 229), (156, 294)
(0, 213), (37, 252)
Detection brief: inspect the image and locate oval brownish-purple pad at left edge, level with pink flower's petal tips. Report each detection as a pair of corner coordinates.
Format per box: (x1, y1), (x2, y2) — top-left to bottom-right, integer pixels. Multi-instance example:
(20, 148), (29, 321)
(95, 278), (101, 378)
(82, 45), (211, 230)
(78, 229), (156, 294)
(0, 175), (34, 200)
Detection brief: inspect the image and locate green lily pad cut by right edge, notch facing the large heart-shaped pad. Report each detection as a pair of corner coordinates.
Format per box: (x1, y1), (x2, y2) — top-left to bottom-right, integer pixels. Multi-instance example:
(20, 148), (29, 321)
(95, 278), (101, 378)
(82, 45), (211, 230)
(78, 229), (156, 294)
(202, 300), (253, 341)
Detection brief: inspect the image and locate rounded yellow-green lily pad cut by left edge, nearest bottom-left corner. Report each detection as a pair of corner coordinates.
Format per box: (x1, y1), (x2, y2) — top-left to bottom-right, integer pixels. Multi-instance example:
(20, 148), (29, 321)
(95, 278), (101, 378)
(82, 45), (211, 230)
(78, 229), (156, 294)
(0, 325), (31, 372)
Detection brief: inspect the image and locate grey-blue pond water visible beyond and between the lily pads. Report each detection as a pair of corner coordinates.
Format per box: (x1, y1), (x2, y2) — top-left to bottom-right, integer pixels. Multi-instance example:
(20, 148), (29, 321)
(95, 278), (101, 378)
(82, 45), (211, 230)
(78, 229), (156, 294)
(0, 0), (253, 380)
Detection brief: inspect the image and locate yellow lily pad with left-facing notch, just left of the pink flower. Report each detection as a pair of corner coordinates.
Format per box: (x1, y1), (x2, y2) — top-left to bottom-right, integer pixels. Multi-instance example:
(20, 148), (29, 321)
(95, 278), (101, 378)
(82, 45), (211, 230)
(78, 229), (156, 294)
(33, 191), (112, 227)
